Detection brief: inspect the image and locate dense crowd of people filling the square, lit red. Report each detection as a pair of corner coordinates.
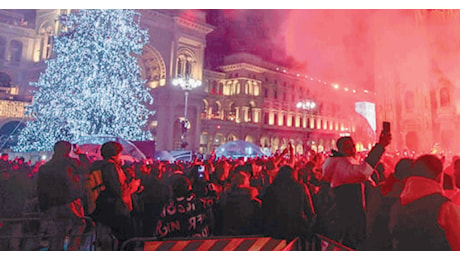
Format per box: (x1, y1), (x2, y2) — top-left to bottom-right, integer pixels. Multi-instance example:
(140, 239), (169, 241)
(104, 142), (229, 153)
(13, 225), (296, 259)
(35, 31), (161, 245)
(0, 127), (460, 250)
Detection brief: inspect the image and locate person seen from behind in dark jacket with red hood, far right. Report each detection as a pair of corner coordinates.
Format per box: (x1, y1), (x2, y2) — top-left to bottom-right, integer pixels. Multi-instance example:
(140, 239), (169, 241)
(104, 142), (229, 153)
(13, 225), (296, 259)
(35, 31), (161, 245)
(389, 154), (460, 251)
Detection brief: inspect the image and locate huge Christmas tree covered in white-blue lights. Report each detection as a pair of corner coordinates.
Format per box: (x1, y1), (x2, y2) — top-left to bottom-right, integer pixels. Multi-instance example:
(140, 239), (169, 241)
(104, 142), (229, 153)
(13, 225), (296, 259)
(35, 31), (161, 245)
(13, 9), (153, 152)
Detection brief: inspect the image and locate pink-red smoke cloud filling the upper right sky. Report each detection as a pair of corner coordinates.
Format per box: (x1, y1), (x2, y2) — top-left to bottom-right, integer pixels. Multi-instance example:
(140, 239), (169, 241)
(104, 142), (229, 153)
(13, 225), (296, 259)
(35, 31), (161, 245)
(211, 9), (460, 153)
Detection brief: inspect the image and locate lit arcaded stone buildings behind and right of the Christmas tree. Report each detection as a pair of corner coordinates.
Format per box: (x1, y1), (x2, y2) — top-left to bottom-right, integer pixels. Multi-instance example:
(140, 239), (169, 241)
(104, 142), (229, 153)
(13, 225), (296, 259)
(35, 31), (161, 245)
(0, 9), (375, 153)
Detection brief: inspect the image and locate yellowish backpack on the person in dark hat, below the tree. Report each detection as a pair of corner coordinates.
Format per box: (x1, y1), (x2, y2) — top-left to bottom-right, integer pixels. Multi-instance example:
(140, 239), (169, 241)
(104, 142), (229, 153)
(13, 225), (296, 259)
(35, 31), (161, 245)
(84, 169), (105, 215)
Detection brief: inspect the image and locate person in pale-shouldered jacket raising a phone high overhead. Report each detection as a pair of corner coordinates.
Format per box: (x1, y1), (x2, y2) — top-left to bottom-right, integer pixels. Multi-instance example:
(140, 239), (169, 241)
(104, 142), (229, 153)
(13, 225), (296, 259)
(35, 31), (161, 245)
(323, 123), (391, 249)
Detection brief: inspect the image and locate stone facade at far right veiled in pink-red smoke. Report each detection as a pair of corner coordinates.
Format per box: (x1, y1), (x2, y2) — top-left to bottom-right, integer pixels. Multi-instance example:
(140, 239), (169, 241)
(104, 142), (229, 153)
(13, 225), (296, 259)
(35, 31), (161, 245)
(374, 10), (460, 155)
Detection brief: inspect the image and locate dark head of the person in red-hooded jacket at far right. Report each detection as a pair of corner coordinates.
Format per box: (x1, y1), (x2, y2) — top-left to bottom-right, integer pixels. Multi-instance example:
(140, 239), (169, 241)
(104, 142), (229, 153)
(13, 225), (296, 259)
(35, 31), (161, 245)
(412, 154), (443, 180)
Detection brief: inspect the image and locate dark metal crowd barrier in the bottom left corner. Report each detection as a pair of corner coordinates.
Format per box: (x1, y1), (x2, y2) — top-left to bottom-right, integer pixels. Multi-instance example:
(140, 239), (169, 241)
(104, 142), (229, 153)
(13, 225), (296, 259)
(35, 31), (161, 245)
(0, 214), (96, 251)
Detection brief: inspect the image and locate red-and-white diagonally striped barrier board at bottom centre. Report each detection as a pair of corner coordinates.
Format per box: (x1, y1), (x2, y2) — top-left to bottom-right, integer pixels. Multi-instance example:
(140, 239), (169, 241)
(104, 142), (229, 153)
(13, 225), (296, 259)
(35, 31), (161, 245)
(120, 236), (299, 251)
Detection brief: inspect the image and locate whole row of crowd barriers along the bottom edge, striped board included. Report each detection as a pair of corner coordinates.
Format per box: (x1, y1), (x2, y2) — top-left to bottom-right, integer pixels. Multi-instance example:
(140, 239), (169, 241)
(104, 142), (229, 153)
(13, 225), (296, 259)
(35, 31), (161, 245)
(0, 217), (354, 251)
